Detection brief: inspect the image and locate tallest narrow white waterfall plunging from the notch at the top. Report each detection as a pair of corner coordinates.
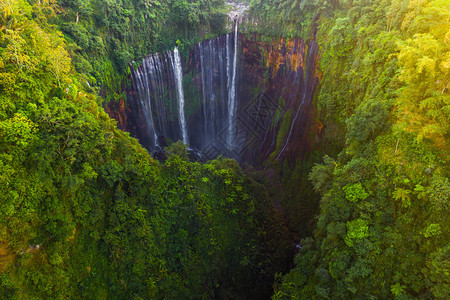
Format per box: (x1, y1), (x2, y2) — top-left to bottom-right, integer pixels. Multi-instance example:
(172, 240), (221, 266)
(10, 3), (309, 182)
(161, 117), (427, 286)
(227, 18), (239, 149)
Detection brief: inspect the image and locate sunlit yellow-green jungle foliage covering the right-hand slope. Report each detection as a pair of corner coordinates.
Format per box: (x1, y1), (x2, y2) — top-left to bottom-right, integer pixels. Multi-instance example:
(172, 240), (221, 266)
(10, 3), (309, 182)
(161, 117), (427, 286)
(251, 0), (450, 299)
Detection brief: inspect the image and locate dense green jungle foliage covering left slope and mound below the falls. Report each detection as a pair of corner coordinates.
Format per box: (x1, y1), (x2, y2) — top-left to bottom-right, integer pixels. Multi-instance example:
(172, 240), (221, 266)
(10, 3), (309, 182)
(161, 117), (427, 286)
(0, 0), (292, 299)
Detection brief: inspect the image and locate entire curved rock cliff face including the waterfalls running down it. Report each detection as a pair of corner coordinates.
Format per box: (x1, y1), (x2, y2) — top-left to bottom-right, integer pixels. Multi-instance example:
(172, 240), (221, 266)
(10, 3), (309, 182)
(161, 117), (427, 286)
(107, 33), (320, 163)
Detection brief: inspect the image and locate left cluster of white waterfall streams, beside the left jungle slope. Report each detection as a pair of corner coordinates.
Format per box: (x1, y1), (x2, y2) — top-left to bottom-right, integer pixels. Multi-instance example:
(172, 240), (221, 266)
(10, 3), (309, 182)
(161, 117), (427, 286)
(129, 49), (188, 151)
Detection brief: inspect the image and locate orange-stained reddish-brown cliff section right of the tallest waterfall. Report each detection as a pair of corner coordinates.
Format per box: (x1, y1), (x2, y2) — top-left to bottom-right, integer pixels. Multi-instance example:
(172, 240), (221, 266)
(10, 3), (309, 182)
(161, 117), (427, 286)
(240, 35), (320, 161)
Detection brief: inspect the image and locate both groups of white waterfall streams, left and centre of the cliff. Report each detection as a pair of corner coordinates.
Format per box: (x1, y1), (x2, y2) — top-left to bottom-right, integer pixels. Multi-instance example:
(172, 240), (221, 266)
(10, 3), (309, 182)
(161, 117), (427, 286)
(131, 22), (243, 156)
